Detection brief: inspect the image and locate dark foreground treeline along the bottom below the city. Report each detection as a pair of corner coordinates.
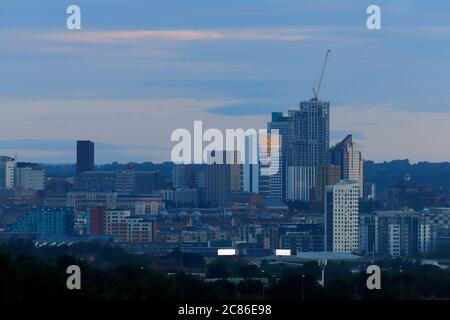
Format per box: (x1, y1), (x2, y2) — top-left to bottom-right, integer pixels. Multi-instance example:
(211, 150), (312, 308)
(0, 242), (450, 300)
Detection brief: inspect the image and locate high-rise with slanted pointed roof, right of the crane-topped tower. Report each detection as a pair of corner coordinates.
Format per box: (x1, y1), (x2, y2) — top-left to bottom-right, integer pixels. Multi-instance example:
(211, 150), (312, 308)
(330, 134), (364, 198)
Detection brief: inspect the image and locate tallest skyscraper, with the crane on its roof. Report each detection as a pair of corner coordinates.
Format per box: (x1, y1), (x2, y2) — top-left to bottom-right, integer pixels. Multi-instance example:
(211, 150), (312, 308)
(286, 99), (330, 201)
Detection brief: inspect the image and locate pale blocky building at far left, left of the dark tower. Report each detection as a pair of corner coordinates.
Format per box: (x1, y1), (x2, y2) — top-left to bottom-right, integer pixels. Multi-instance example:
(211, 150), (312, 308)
(14, 162), (45, 191)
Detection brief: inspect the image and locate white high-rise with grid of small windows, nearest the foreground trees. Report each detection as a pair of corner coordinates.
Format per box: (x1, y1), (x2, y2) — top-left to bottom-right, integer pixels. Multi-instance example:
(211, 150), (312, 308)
(325, 180), (359, 253)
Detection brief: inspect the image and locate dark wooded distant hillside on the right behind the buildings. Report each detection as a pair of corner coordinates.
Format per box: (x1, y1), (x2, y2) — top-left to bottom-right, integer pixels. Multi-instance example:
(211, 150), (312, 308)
(365, 160), (450, 191)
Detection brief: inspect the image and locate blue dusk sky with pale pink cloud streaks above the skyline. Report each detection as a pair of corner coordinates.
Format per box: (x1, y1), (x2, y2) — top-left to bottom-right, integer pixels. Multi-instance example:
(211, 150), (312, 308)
(0, 0), (450, 163)
